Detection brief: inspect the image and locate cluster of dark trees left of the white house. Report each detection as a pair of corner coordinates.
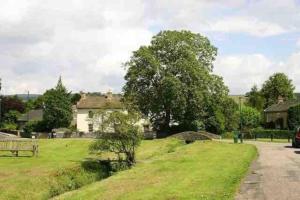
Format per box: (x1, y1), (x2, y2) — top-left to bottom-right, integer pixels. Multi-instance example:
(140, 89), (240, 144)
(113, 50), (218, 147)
(1, 78), (75, 132)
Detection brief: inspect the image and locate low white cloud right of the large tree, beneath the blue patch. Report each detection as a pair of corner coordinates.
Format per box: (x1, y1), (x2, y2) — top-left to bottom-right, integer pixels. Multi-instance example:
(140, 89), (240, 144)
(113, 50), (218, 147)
(214, 52), (300, 94)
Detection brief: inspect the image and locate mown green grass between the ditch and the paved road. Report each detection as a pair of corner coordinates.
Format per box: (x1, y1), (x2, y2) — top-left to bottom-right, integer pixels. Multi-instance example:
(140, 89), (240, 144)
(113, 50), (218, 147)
(57, 140), (257, 200)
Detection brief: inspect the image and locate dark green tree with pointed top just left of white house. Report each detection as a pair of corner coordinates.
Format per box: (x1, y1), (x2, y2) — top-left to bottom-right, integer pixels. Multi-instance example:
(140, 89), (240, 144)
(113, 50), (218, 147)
(43, 77), (73, 130)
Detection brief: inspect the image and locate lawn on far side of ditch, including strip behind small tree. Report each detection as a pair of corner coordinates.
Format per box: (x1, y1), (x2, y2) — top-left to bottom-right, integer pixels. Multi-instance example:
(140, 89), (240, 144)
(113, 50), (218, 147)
(0, 139), (182, 200)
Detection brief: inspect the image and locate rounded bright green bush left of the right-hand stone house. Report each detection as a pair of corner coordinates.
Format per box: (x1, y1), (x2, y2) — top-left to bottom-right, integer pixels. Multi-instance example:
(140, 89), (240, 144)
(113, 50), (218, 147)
(241, 106), (261, 130)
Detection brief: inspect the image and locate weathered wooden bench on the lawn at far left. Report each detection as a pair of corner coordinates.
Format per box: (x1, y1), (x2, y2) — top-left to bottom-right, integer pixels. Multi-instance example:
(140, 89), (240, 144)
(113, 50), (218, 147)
(0, 138), (39, 156)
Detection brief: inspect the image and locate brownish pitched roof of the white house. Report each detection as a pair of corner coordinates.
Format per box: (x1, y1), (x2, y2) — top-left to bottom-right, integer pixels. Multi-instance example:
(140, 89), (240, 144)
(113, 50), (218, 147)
(77, 94), (123, 109)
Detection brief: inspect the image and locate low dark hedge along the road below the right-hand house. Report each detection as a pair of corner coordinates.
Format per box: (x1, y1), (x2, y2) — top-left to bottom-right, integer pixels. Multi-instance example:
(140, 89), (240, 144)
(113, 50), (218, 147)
(249, 128), (294, 139)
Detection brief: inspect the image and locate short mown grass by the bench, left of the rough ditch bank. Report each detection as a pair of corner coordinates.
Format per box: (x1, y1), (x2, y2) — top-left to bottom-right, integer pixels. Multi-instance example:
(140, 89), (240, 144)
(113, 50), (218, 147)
(0, 140), (91, 199)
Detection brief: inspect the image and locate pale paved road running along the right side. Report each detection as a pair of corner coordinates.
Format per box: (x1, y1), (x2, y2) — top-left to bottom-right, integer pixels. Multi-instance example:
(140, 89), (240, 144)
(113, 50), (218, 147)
(236, 142), (300, 200)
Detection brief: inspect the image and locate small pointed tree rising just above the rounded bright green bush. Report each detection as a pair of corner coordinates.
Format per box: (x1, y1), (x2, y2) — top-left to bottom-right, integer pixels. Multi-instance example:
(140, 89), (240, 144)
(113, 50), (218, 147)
(246, 85), (266, 112)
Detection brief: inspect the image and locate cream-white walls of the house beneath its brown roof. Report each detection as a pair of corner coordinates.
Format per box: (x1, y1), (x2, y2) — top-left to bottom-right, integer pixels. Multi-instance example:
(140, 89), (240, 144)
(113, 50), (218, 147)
(76, 109), (150, 133)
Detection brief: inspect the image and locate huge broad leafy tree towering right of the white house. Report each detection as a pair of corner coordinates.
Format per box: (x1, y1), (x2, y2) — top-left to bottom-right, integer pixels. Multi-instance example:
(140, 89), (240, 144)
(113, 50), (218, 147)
(124, 31), (233, 133)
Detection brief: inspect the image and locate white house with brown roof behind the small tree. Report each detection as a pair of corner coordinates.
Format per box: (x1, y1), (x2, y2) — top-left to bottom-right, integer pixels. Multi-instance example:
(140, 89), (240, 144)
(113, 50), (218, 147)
(76, 92), (150, 133)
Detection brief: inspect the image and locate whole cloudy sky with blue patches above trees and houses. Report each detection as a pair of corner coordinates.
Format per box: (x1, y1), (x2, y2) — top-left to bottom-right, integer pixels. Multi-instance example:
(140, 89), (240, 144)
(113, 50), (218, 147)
(0, 0), (300, 94)
